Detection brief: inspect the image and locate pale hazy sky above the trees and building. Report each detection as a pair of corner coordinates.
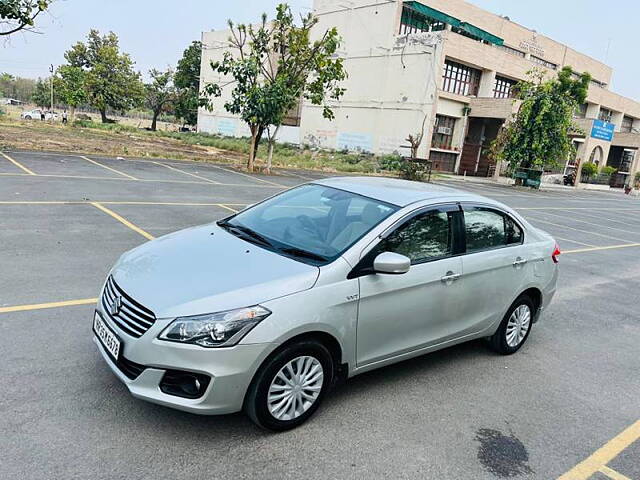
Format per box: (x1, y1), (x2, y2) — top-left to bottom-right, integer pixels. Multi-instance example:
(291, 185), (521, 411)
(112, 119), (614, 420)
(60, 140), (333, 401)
(0, 0), (640, 101)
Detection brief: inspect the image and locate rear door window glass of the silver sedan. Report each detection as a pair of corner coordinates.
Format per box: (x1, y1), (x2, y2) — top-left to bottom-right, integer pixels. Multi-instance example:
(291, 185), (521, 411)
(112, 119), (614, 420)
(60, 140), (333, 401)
(464, 208), (507, 253)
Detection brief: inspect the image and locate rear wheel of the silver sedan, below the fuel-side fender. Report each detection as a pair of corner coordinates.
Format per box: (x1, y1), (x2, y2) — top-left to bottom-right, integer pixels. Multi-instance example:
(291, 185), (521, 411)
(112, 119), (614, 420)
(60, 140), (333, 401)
(489, 295), (535, 355)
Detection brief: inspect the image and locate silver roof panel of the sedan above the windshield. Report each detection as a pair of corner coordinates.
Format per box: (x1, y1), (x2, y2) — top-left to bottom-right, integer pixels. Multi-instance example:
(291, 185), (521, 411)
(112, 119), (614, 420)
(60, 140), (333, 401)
(313, 177), (496, 207)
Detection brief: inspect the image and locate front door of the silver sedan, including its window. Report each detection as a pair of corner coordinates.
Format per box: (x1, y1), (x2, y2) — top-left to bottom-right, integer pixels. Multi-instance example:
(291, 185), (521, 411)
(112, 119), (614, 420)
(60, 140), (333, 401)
(356, 205), (462, 366)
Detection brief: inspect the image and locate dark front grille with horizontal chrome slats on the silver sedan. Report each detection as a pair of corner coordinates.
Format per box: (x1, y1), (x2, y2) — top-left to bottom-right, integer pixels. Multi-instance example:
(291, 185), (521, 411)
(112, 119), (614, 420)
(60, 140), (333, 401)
(102, 276), (156, 338)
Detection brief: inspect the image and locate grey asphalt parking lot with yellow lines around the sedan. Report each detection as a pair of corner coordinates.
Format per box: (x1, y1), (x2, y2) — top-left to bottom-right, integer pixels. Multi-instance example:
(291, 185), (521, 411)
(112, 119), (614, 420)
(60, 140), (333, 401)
(0, 152), (640, 480)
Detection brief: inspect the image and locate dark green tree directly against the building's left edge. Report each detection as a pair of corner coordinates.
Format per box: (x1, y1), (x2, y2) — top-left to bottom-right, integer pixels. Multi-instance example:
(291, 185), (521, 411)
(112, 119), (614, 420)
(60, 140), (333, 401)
(173, 41), (202, 125)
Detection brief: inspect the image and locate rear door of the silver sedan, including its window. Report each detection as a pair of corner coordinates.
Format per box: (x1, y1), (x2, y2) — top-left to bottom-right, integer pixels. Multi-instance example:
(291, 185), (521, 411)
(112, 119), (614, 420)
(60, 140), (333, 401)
(460, 204), (531, 334)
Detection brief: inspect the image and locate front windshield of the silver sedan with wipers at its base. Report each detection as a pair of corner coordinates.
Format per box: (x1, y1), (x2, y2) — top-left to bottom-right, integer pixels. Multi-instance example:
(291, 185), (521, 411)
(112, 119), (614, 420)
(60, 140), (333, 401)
(218, 184), (398, 265)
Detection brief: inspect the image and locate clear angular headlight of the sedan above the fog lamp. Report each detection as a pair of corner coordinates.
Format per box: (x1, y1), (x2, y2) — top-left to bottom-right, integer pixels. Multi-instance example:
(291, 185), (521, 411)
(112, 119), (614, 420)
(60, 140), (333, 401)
(158, 305), (271, 347)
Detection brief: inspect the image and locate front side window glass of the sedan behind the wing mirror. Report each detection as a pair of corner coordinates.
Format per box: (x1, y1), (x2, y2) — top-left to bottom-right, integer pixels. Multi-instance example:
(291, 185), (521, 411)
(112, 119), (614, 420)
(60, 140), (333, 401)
(377, 210), (453, 265)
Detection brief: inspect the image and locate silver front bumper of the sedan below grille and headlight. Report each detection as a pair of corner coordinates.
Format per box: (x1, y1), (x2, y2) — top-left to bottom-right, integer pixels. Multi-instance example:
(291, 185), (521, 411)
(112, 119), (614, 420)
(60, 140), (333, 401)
(93, 310), (275, 415)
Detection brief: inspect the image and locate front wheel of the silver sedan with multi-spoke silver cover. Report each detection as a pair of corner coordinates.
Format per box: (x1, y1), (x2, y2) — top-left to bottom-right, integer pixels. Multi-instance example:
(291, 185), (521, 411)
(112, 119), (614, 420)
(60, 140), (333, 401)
(244, 340), (335, 431)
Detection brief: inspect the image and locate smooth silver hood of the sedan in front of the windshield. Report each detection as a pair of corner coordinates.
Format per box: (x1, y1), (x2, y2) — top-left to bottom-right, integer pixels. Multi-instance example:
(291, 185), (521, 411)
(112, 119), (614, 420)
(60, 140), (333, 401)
(111, 224), (320, 318)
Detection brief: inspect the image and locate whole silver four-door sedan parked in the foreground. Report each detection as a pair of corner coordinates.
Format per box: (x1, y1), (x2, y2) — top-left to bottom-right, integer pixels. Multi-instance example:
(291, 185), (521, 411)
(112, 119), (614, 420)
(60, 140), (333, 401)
(93, 177), (560, 430)
